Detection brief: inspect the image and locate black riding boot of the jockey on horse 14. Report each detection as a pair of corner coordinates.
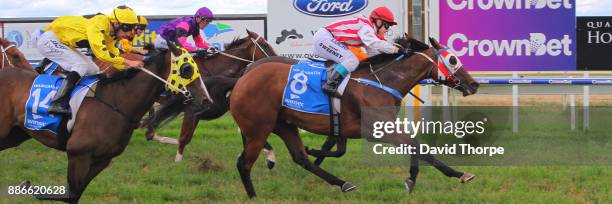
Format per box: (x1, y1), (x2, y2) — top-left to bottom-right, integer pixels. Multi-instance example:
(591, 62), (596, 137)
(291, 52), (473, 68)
(48, 72), (81, 115)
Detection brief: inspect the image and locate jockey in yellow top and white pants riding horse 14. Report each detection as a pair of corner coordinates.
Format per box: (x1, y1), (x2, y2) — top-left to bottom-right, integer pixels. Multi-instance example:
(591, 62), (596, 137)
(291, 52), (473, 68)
(37, 6), (143, 115)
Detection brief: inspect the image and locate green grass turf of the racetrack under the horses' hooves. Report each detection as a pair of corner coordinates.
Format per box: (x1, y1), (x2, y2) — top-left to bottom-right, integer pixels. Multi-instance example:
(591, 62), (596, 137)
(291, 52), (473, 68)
(0, 115), (612, 203)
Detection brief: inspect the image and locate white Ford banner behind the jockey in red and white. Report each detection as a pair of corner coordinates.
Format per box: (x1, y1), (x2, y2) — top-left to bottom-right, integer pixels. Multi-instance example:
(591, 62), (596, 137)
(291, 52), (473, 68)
(268, 0), (408, 59)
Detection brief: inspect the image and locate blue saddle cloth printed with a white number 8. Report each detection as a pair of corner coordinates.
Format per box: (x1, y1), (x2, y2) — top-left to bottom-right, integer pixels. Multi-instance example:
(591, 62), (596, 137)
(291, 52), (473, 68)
(283, 60), (329, 115)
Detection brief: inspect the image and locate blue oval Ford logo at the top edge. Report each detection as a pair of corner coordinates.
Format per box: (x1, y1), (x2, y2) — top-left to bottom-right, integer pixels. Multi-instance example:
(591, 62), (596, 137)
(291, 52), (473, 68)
(293, 0), (368, 17)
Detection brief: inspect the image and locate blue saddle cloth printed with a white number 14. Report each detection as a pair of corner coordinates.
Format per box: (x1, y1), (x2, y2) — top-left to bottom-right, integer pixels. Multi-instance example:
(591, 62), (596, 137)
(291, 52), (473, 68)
(24, 74), (100, 134)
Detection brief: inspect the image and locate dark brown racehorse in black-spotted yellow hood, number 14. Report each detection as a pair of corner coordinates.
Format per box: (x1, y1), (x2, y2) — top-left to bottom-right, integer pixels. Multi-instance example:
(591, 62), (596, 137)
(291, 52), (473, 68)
(0, 41), (204, 203)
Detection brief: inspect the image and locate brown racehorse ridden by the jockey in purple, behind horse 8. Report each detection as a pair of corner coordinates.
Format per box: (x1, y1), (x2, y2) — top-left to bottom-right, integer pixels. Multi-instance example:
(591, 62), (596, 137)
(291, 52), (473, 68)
(143, 30), (276, 162)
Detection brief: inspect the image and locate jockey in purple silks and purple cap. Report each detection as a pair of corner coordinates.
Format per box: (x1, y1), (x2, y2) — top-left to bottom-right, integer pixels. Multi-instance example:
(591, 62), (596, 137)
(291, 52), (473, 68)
(155, 7), (215, 52)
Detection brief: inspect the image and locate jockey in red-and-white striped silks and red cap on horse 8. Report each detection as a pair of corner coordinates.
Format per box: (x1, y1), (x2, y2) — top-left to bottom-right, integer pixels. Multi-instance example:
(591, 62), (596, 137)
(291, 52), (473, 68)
(313, 6), (400, 95)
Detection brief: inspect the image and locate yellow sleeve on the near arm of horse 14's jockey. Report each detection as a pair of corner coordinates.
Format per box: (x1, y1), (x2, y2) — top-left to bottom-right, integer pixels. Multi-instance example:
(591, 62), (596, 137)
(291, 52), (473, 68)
(87, 22), (125, 69)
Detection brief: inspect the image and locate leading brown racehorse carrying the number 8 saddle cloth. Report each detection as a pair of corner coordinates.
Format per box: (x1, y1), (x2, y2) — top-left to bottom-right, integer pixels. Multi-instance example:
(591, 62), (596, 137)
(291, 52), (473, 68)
(230, 35), (478, 197)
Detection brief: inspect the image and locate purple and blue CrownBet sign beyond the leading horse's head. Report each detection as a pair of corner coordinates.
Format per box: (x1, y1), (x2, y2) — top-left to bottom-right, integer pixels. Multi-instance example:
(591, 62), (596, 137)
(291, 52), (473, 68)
(440, 0), (576, 71)
